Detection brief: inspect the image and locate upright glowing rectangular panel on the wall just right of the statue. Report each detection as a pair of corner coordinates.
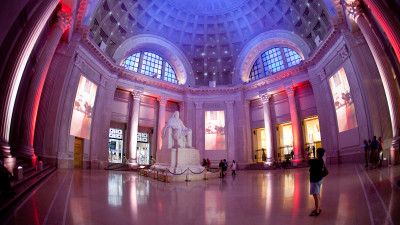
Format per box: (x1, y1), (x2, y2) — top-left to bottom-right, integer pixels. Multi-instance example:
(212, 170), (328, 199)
(205, 111), (226, 150)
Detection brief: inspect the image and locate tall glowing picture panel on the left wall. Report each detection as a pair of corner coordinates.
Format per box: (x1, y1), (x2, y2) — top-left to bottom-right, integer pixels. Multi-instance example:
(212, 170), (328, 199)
(70, 76), (97, 139)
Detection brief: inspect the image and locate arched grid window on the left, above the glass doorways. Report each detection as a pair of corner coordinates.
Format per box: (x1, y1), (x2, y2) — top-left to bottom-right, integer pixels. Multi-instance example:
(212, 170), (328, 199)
(122, 51), (178, 84)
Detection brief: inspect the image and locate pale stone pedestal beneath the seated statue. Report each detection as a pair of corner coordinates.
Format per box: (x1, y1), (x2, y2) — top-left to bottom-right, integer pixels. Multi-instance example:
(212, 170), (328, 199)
(152, 148), (204, 173)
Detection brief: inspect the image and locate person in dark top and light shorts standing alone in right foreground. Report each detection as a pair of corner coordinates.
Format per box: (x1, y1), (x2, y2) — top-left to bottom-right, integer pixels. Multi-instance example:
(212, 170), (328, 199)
(308, 148), (325, 216)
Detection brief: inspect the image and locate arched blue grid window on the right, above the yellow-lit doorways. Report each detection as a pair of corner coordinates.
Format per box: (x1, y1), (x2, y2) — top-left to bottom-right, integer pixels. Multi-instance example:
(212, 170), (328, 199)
(249, 47), (303, 81)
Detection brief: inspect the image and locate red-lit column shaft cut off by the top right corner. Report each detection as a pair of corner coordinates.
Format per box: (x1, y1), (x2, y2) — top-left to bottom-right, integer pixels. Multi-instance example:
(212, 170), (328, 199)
(364, 0), (400, 62)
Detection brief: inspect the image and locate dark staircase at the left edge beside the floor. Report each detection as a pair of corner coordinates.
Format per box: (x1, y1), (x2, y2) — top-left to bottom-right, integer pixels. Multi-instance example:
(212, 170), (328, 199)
(0, 158), (56, 213)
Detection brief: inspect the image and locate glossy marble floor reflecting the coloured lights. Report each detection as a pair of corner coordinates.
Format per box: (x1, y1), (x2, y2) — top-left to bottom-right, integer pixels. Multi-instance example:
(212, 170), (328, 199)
(0, 164), (400, 225)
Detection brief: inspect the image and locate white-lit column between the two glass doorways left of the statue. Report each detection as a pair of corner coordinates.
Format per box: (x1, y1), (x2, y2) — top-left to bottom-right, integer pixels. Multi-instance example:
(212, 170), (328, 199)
(128, 90), (143, 169)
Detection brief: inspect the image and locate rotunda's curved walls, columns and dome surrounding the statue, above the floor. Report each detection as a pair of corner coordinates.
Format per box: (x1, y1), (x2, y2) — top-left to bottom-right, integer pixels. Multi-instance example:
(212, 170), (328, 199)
(0, 0), (400, 174)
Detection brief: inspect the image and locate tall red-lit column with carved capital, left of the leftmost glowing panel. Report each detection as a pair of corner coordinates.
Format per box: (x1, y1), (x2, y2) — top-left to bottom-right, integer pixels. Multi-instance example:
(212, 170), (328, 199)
(16, 12), (72, 159)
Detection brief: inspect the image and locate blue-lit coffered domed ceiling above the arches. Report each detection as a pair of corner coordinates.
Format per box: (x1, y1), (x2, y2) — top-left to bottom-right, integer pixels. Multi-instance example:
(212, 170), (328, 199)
(90, 0), (331, 86)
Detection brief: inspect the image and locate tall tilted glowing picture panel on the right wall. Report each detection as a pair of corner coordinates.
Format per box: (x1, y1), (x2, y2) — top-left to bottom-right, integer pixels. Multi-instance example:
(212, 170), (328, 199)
(329, 68), (357, 133)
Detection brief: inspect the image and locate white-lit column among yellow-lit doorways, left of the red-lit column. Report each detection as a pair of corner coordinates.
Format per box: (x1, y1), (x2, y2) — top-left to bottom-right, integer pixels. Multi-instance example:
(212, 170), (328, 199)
(259, 93), (274, 164)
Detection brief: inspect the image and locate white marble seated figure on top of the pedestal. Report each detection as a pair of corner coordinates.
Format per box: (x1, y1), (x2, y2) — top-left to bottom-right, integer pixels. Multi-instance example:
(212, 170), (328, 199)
(161, 111), (192, 149)
